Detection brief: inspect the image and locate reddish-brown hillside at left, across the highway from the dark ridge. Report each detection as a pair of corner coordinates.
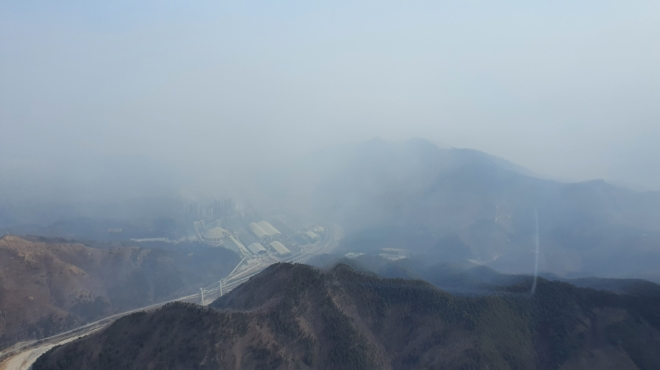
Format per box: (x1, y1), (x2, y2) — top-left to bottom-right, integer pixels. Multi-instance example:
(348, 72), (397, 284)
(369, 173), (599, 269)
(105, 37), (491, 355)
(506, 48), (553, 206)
(0, 235), (239, 348)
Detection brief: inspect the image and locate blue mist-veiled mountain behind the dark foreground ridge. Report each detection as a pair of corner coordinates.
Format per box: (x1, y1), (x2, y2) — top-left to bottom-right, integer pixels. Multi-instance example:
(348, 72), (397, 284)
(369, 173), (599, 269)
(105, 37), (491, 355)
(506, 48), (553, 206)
(272, 139), (660, 281)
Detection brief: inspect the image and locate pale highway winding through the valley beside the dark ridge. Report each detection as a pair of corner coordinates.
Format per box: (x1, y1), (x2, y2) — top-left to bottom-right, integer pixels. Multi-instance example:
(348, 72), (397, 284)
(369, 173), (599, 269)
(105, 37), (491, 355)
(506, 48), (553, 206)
(0, 226), (341, 370)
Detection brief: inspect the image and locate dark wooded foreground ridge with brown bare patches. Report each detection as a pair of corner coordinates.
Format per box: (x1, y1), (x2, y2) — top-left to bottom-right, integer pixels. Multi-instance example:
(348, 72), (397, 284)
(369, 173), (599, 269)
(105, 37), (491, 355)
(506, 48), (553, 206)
(34, 264), (660, 370)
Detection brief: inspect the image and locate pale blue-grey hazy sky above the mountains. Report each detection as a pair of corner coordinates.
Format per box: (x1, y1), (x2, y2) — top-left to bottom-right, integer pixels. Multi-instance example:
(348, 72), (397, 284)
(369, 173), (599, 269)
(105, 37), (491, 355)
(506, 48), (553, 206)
(0, 0), (660, 199)
